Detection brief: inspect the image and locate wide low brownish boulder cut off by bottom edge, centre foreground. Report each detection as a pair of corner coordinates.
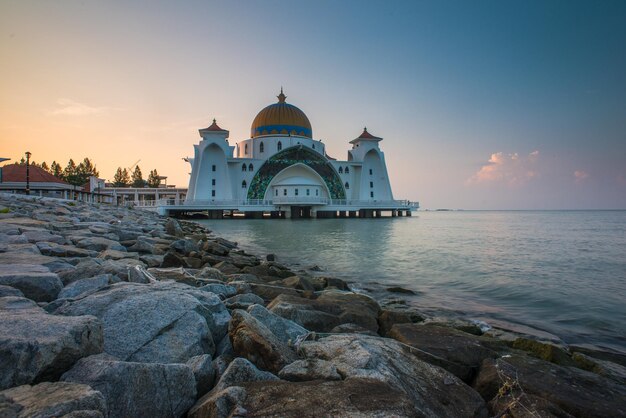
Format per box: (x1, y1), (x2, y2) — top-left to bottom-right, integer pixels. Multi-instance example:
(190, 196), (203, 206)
(188, 378), (420, 418)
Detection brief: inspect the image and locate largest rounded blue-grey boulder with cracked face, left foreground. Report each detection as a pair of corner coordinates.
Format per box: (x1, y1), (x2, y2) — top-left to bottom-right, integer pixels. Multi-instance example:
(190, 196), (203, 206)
(55, 282), (230, 363)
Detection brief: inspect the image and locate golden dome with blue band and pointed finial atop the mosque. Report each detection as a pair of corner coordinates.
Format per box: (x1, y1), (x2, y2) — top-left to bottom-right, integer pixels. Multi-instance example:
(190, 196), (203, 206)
(250, 88), (313, 138)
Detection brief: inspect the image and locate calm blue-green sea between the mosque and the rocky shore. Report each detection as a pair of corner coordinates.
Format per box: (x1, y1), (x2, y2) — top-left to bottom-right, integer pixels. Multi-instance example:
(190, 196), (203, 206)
(193, 211), (626, 351)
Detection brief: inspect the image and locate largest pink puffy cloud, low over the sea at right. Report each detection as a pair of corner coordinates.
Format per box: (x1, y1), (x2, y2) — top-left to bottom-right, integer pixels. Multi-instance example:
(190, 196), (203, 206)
(465, 151), (539, 186)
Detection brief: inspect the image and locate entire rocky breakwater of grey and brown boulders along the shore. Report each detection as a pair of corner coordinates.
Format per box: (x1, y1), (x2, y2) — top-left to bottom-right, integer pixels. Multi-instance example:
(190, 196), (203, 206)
(0, 195), (626, 418)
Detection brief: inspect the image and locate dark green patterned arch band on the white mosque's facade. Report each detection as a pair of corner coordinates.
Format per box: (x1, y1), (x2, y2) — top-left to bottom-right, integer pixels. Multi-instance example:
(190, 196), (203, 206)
(248, 145), (346, 199)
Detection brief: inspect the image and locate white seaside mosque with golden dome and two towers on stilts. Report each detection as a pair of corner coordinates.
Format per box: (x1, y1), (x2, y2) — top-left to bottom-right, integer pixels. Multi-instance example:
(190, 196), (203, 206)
(178, 88), (418, 218)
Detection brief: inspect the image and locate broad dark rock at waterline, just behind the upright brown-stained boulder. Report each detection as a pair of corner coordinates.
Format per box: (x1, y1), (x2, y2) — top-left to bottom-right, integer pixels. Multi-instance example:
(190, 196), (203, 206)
(267, 291), (380, 332)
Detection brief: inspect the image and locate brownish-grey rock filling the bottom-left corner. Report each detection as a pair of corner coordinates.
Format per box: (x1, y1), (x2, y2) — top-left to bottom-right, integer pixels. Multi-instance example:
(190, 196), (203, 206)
(0, 382), (107, 418)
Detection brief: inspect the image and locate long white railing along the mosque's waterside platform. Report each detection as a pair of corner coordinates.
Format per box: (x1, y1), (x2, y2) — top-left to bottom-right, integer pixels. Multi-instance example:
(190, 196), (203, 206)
(133, 196), (419, 209)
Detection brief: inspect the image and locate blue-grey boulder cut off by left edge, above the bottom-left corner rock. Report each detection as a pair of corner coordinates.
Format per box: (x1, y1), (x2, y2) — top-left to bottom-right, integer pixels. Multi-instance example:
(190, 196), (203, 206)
(0, 297), (103, 389)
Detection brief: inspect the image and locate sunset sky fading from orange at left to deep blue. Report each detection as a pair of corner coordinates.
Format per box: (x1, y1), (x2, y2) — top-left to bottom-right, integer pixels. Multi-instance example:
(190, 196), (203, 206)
(0, 0), (626, 209)
